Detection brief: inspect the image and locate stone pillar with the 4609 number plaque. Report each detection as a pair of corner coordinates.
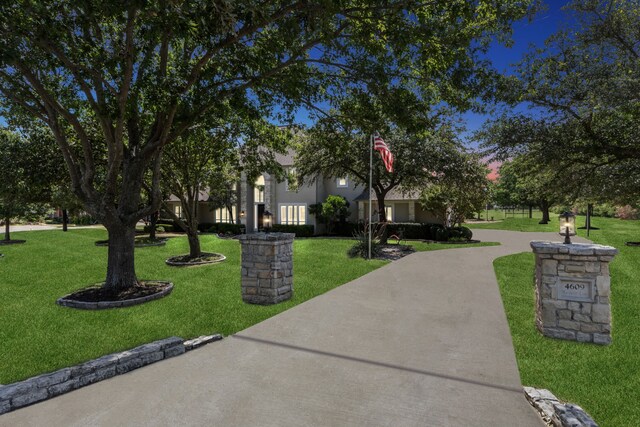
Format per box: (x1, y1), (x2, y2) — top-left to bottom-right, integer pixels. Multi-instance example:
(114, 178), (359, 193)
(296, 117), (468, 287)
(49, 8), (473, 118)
(531, 241), (618, 345)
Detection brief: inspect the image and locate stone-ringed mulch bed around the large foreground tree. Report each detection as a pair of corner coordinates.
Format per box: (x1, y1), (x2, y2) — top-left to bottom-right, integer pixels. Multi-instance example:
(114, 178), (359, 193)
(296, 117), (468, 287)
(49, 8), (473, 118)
(58, 280), (173, 310)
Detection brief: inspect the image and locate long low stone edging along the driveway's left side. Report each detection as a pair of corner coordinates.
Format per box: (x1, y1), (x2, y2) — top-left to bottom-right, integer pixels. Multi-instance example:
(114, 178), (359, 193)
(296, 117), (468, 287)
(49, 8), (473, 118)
(0, 334), (222, 414)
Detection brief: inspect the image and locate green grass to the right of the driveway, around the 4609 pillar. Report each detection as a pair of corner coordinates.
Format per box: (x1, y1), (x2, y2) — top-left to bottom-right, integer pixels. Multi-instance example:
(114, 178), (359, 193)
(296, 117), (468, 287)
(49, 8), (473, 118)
(482, 218), (640, 427)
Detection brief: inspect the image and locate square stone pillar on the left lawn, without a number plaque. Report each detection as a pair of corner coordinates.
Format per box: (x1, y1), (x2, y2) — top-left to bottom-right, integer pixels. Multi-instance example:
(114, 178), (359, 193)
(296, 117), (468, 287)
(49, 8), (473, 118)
(240, 233), (295, 305)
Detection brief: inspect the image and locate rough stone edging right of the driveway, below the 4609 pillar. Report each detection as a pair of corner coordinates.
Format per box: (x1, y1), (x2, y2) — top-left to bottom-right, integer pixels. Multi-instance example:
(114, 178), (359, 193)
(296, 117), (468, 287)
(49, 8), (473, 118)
(524, 387), (598, 427)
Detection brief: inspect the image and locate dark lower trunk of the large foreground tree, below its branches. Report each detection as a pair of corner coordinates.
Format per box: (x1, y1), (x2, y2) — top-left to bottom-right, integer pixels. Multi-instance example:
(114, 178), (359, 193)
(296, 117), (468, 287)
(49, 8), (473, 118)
(104, 221), (138, 292)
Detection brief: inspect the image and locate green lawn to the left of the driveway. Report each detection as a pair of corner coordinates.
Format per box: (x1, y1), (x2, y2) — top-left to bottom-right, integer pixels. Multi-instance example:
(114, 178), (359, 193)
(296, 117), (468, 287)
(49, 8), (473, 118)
(0, 229), (491, 384)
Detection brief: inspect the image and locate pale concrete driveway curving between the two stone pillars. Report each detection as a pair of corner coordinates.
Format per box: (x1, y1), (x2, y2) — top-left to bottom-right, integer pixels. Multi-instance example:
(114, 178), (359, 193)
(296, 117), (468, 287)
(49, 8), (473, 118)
(0, 230), (592, 426)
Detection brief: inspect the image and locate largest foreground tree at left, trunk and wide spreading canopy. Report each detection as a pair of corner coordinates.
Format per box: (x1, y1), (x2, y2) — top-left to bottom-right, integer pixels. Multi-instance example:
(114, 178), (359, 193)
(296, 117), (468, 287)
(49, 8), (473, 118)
(0, 0), (530, 289)
